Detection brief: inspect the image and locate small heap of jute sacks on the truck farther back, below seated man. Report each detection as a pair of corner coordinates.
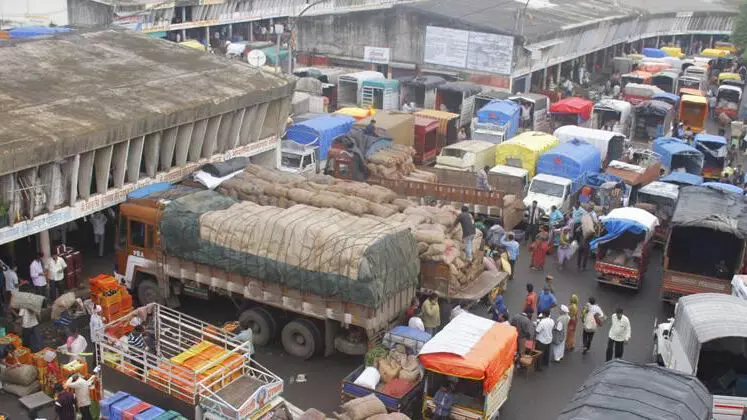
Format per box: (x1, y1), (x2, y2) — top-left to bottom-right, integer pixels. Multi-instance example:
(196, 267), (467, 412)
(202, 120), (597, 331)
(366, 144), (437, 182)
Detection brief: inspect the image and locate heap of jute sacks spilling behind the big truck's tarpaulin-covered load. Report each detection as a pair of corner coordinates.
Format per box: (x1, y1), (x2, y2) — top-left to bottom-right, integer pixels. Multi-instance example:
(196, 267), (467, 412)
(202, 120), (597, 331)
(388, 206), (482, 289)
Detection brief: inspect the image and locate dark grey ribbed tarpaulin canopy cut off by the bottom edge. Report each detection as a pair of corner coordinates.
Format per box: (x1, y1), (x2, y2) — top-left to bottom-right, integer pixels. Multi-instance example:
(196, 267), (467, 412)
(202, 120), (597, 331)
(558, 359), (713, 420)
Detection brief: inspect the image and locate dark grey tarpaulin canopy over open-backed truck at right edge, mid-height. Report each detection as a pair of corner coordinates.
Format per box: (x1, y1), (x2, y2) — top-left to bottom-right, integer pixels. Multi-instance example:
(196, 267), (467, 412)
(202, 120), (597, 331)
(672, 185), (747, 239)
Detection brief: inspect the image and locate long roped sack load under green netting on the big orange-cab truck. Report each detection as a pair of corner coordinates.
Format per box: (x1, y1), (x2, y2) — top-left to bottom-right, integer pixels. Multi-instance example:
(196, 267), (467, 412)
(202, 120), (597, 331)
(160, 191), (419, 307)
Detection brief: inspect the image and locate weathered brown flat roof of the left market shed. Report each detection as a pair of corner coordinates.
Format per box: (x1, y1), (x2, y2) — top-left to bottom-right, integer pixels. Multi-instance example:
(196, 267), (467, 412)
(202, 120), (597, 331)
(0, 30), (293, 174)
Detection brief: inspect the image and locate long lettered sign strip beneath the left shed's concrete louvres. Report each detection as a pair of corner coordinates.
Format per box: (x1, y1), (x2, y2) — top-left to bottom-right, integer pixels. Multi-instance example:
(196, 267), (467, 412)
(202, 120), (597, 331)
(0, 136), (280, 244)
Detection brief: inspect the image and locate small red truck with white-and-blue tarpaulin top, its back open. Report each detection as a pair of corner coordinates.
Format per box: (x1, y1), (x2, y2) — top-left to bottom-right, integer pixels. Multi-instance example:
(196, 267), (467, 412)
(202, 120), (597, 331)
(590, 207), (659, 289)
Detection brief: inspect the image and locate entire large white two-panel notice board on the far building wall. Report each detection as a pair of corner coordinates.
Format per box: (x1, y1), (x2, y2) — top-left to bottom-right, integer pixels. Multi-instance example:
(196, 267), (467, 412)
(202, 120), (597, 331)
(423, 26), (514, 75)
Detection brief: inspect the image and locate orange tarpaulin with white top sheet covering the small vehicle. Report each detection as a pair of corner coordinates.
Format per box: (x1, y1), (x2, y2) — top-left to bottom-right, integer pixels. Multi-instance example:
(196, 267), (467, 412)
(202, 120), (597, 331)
(418, 312), (518, 395)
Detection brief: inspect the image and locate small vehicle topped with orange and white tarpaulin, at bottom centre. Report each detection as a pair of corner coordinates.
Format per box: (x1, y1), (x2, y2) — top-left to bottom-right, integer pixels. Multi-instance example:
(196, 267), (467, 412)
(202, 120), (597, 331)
(418, 312), (517, 420)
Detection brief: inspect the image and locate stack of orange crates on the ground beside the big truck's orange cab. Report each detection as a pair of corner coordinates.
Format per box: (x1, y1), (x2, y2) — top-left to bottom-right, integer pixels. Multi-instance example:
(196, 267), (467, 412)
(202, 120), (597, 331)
(88, 274), (132, 338)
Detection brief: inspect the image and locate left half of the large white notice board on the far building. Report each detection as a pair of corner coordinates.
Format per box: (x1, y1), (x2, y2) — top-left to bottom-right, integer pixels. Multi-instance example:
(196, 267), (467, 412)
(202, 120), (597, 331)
(423, 26), (469, 68)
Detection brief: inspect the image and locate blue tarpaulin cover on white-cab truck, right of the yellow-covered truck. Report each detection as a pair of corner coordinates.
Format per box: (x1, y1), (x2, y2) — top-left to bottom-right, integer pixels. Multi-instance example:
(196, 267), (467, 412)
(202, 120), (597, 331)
(537, 140), (602, 180)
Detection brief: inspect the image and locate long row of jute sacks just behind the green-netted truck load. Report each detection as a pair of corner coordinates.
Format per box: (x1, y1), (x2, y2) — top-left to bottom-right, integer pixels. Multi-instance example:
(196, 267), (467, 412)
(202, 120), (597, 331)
(218, 165), (409, 218)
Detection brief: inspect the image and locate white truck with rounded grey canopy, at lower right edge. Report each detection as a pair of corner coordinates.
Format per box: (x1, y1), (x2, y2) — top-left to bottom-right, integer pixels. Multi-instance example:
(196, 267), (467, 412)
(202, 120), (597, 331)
(653, 293), (747, 420)
